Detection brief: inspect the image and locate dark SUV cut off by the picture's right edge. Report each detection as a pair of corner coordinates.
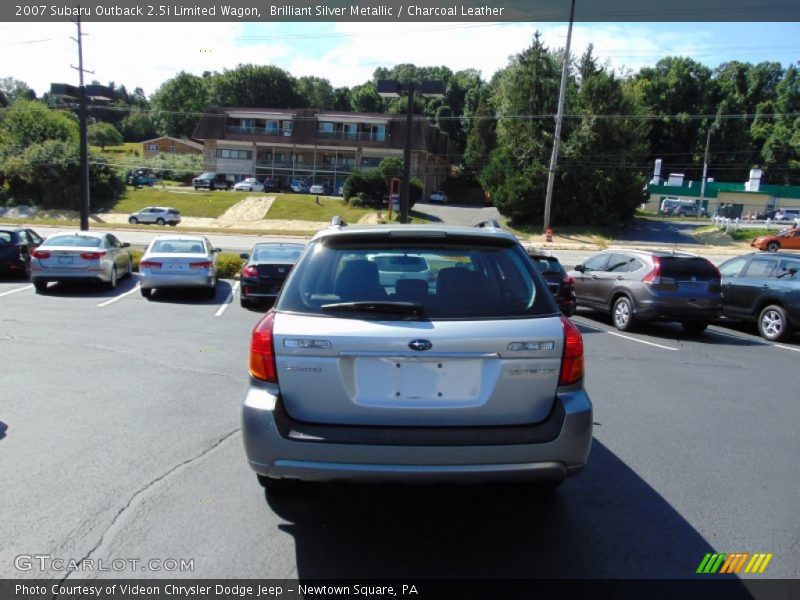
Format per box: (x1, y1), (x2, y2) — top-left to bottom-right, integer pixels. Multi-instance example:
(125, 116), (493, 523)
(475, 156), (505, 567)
(719, 252), (800, 342)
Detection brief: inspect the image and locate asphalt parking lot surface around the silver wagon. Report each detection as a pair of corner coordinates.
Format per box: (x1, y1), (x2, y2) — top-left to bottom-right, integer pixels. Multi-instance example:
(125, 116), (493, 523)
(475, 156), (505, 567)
(0, 277), (800, 579)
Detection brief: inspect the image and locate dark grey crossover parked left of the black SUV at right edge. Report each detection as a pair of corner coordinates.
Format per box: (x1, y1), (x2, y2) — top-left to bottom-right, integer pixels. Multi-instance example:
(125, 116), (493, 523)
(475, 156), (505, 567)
(569, 250), (722, 334)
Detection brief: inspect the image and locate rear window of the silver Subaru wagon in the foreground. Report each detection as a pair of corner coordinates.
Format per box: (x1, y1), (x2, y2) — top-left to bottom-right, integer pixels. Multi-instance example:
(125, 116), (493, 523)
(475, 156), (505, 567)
(276, 236), (557, 319)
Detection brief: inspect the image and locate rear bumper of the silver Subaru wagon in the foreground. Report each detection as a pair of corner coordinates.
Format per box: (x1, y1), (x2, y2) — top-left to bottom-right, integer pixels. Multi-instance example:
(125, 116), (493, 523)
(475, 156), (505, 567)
(242, 385), (592, 482)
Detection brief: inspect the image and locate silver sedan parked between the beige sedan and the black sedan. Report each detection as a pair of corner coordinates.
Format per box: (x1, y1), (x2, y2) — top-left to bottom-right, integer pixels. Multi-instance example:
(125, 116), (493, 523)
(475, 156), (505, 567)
(139, 235), (219, 298)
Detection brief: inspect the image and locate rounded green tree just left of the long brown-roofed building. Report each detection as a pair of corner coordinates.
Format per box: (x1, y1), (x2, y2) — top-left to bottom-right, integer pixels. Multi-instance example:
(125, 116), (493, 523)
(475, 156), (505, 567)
(150, 71), (209, 137)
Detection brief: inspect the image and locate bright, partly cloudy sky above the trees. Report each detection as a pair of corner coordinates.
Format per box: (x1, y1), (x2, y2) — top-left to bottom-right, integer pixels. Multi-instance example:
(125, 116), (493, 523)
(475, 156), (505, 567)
(0, 22), (800, 96)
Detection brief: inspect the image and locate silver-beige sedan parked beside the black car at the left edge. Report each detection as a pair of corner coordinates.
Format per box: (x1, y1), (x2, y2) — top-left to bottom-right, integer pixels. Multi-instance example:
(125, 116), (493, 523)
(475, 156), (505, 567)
(31, 231), (133, 294)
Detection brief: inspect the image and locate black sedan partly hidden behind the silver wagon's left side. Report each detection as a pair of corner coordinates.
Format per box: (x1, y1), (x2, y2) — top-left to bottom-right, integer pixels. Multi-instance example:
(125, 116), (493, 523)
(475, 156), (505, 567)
(239, 243), (305, 308)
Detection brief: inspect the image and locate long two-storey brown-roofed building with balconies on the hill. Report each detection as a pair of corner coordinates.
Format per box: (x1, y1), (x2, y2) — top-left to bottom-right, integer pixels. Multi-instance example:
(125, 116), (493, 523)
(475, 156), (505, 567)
(192, 108), (452, 196)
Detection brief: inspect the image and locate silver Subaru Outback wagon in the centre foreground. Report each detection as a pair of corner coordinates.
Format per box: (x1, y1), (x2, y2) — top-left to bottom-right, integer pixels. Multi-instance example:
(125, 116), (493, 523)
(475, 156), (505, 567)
(242, 223), (592, 493)
